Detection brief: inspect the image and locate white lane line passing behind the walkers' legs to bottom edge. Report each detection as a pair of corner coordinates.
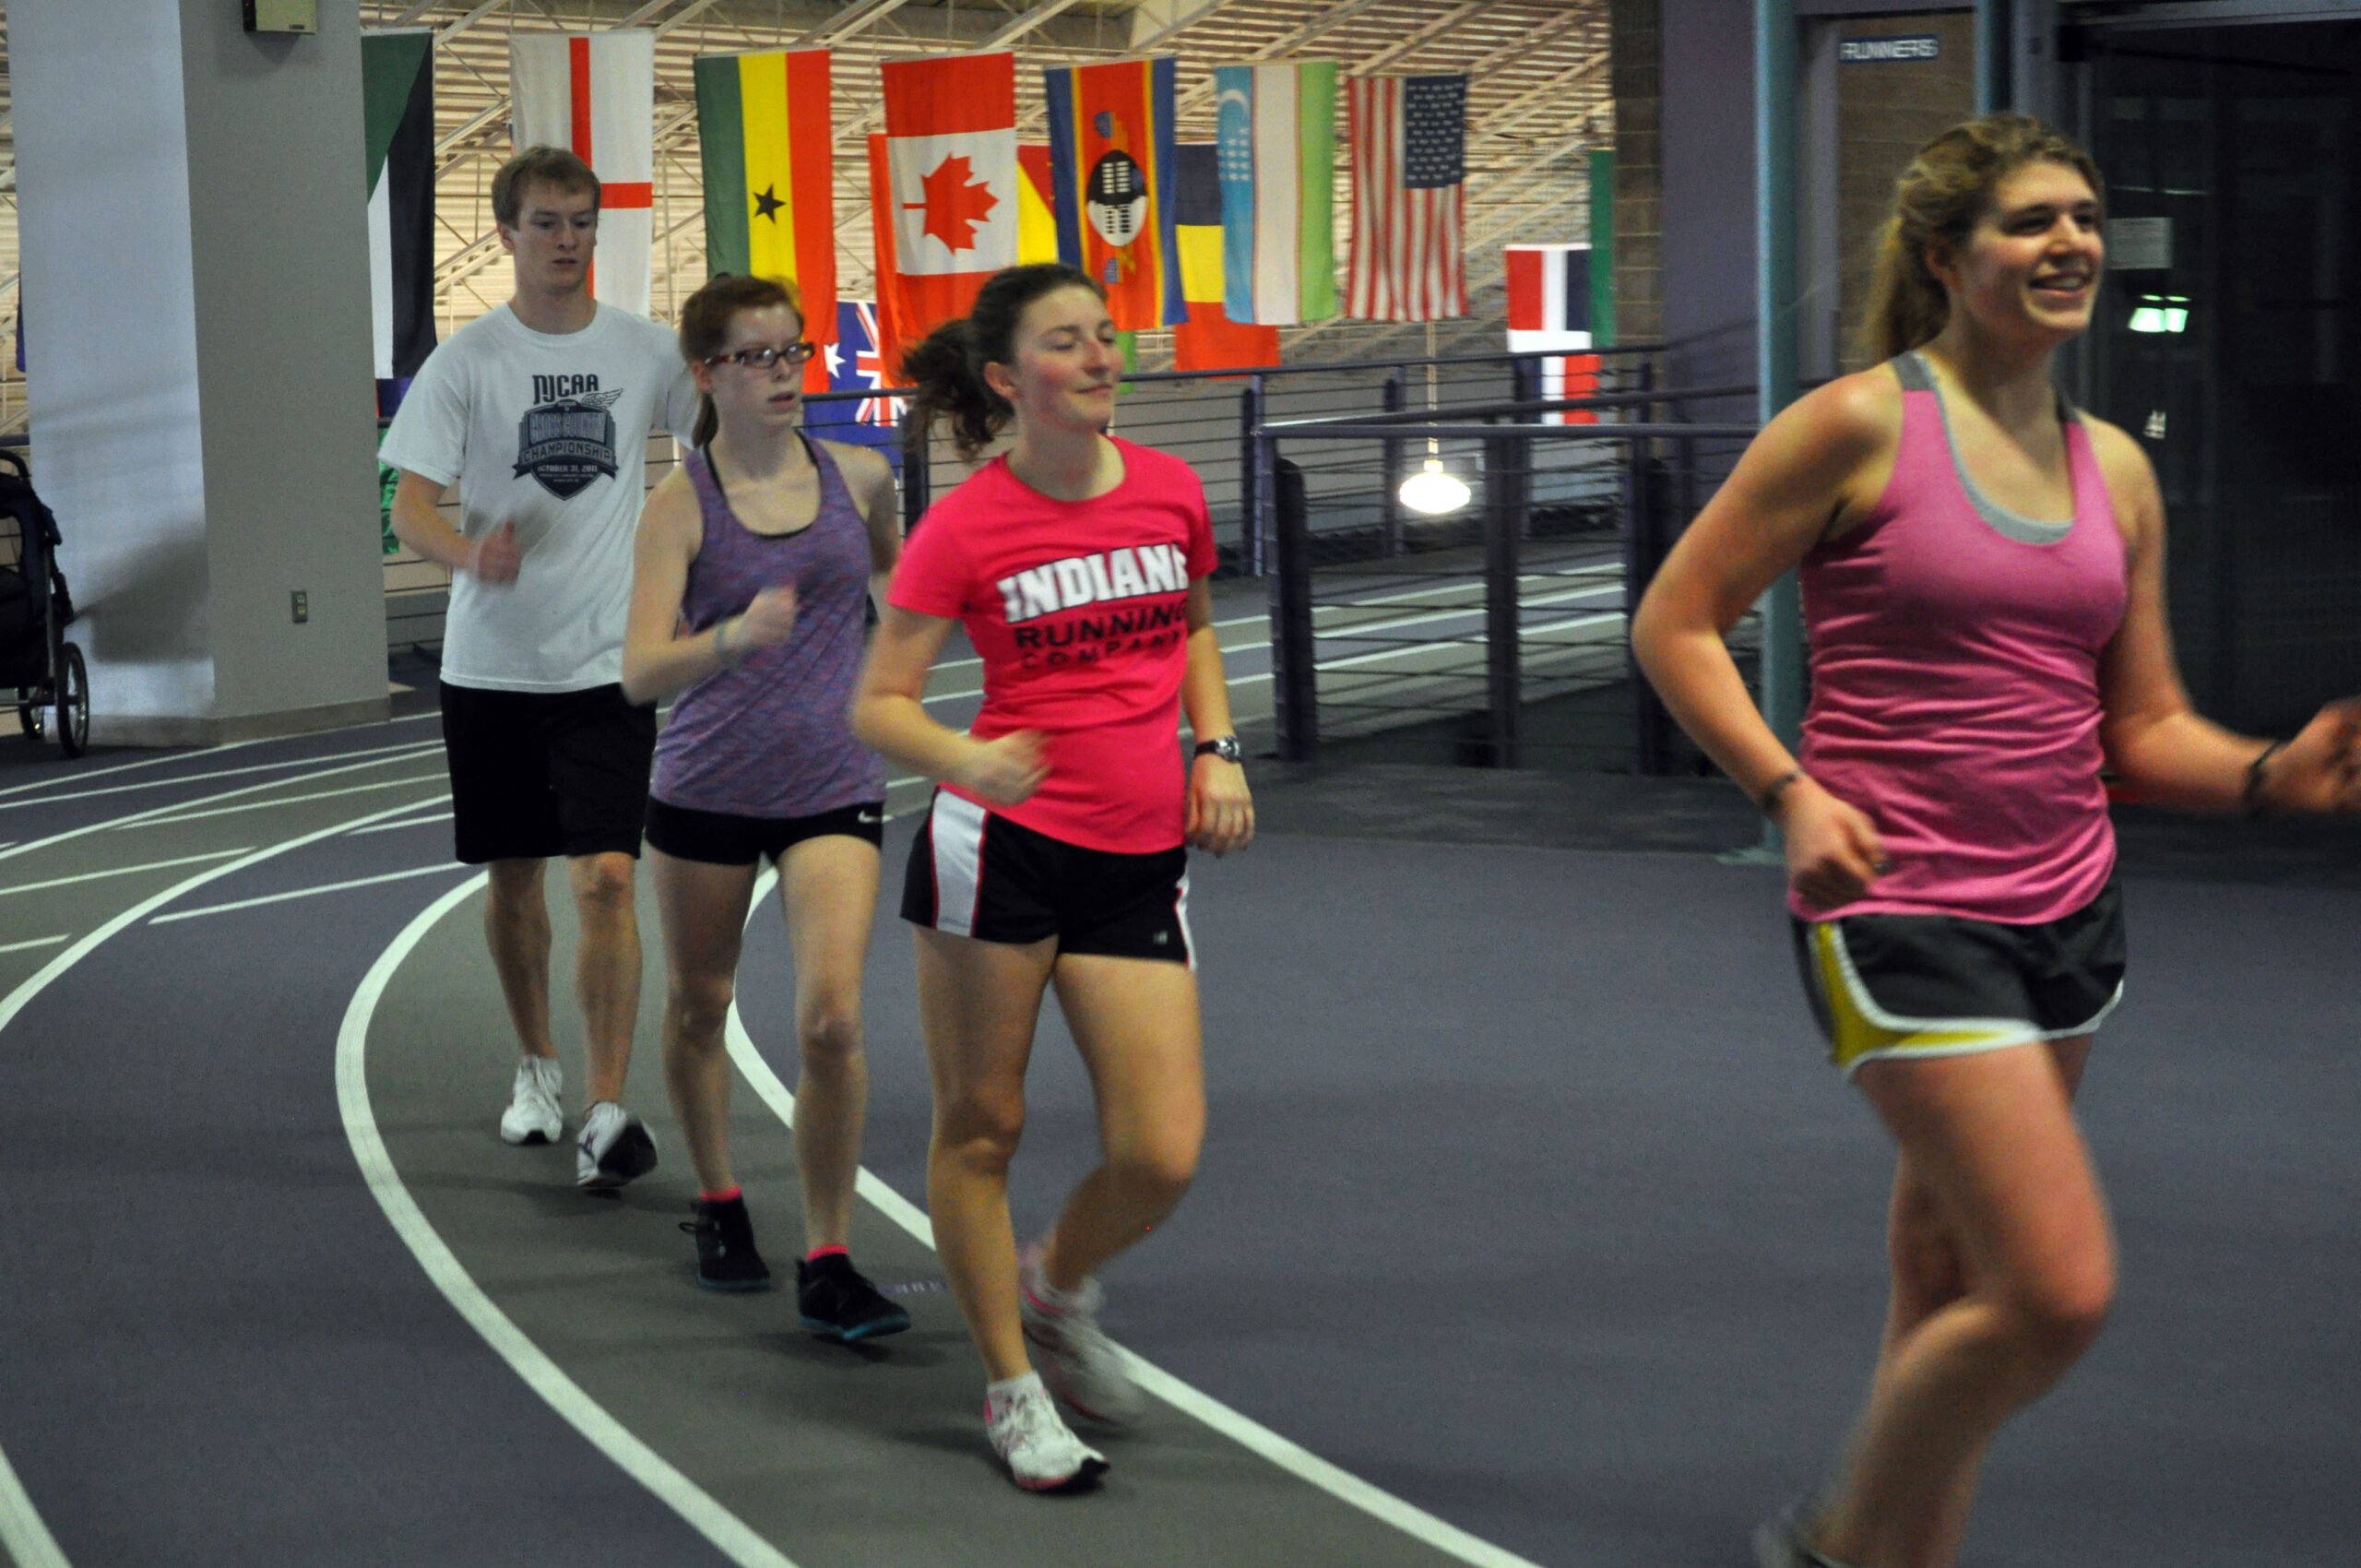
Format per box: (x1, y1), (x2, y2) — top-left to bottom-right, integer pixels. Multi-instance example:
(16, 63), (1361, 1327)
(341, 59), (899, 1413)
(718, 869), (1539, 1568)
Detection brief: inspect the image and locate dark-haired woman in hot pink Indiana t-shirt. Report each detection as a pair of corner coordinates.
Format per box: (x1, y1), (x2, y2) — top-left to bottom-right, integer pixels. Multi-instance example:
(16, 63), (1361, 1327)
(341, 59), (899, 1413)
(852, 265), (1253, 1491)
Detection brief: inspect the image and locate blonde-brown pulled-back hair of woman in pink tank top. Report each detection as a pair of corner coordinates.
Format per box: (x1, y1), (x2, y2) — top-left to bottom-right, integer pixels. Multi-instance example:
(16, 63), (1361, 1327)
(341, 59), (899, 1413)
(1860, 113), (2106, 362)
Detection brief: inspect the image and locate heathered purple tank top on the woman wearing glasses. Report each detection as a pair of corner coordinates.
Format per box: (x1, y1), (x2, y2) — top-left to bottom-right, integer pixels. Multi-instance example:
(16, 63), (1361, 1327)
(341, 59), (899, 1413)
(652, 439), (885, 817)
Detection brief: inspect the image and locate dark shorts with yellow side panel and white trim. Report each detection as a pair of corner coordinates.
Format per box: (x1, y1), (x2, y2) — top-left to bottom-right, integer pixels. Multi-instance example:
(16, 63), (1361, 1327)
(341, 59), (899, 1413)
(1792, 884), (2125, 1076)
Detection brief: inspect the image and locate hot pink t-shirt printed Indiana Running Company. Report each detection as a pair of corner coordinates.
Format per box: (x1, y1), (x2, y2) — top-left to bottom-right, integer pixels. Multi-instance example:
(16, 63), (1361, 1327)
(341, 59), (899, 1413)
(888, 437), (1216, 855)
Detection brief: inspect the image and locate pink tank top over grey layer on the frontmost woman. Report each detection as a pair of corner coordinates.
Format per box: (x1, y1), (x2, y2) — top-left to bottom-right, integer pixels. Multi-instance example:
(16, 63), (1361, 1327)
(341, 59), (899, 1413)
(1789, 354), (2125, 926)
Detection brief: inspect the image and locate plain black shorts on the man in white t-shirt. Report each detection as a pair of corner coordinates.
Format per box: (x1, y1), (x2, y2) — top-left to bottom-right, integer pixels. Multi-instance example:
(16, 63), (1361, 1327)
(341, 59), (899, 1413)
(442, 683), (657, 867)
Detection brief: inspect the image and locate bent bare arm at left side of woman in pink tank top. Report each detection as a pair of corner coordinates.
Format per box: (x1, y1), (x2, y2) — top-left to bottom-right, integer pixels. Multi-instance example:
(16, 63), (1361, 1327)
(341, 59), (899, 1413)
(1631, 371), (1901, 907)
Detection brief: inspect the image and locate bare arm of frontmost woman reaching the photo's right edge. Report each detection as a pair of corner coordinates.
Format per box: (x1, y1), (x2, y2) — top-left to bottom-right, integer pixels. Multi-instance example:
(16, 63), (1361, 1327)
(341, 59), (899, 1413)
(2090, 421), (2361, 813)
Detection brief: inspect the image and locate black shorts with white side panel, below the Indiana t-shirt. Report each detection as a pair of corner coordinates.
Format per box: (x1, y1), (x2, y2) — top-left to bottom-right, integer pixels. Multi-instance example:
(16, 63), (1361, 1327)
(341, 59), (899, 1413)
(902, 789), (1197, 968)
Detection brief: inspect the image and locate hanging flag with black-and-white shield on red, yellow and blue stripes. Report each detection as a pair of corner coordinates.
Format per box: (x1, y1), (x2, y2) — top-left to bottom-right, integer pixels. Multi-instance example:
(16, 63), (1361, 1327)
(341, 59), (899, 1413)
(1041, 54), (1188, 333)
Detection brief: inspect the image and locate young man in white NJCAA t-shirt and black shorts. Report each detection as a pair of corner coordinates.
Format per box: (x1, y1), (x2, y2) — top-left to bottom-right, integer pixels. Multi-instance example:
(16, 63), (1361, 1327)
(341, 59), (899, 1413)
(383, 147), (696, 1190)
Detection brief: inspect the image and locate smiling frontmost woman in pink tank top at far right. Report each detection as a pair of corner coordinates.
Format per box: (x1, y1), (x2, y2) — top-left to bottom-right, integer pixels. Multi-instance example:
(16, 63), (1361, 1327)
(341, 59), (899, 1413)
(1631, 115), (2361, 1568)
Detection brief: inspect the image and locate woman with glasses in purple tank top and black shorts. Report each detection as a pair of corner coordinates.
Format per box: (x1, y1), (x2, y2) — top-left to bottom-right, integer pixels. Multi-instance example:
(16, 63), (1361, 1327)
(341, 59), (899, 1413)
(623, 274), (909, 1341)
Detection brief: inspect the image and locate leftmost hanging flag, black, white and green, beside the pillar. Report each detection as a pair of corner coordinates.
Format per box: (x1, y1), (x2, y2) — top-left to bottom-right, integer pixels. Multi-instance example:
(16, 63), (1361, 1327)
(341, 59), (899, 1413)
(362, 29), (434, 380)
